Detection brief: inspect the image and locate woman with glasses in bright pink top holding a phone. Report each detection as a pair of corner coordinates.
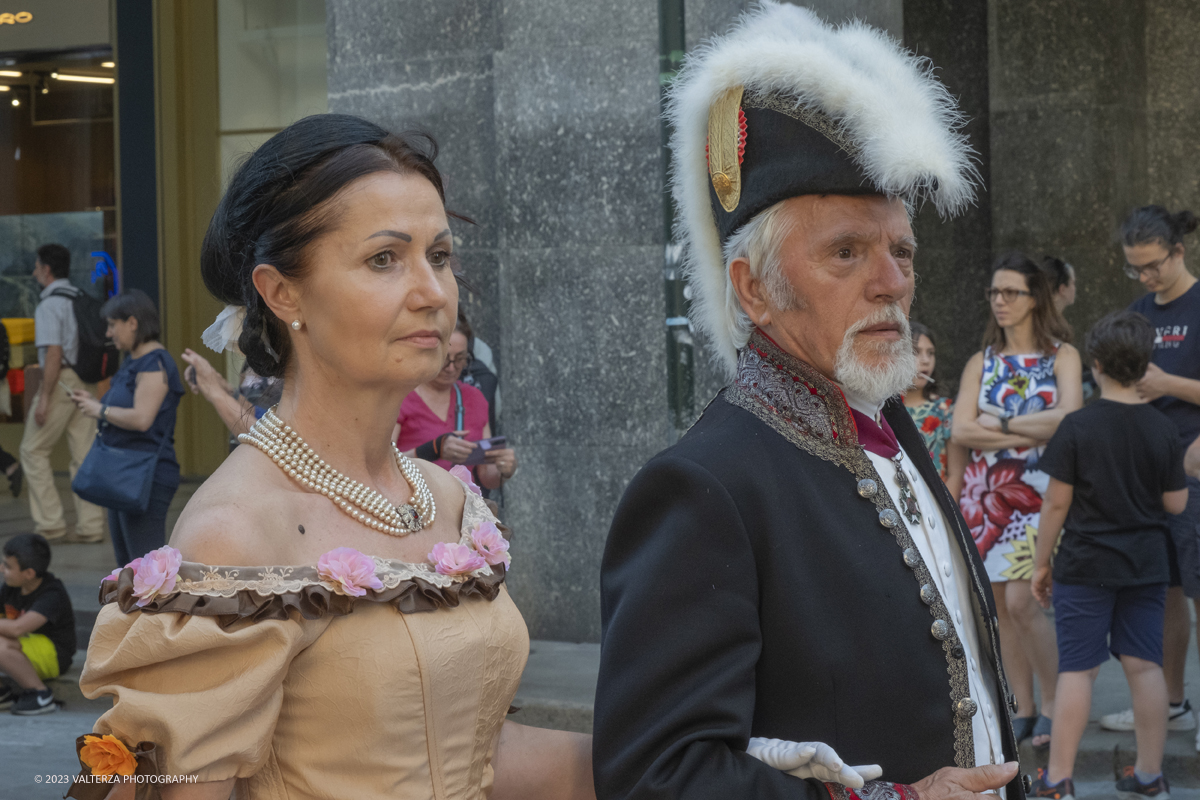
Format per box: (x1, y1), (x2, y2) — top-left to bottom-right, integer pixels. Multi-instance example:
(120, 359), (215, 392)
(396, 315), (517, 489)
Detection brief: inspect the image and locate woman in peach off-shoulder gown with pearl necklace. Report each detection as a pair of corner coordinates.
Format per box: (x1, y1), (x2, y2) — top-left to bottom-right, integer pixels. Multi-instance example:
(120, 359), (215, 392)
(66, 114), (592, 800)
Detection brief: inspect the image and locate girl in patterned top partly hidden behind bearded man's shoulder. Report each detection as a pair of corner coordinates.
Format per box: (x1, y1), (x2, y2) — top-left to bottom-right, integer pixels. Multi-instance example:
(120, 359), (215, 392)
(904, 320), (967, 499)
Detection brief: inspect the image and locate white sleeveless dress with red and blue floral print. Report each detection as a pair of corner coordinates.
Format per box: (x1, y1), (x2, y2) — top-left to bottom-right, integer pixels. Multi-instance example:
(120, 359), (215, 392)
(959, 348), (1058, 583)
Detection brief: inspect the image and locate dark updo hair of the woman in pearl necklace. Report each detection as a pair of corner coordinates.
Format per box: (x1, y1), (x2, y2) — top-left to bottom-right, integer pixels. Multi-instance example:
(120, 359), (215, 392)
(200, 114), (455, 378)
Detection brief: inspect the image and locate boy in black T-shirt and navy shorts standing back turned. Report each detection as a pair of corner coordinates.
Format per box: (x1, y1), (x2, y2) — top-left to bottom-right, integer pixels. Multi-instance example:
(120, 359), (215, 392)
(1031, 311), (1188, 799)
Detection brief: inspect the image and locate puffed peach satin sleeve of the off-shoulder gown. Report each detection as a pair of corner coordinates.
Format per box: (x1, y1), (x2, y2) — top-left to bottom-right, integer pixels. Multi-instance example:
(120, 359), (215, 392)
(79, 603), (326, 782)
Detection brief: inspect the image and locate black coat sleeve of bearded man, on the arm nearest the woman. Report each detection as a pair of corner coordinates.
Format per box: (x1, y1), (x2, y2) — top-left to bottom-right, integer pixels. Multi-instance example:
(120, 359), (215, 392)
(593, 457), (829, 800)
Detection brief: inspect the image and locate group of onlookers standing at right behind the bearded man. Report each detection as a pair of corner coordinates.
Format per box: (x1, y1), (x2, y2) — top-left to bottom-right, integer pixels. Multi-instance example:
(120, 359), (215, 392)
(904, 206), (1200, 798)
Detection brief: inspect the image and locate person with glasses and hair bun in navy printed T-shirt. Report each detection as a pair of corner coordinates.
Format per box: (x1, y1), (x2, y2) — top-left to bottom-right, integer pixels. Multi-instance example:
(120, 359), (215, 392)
(1100, 205), (1200, 750)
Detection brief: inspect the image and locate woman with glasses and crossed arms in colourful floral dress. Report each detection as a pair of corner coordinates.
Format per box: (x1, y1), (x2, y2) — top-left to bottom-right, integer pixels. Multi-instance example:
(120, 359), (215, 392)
(953, 253), (1082, 747)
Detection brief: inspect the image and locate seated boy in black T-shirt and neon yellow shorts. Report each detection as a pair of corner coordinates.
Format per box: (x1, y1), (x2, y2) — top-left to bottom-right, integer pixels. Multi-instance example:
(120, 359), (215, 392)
(0, 534), (76, 716)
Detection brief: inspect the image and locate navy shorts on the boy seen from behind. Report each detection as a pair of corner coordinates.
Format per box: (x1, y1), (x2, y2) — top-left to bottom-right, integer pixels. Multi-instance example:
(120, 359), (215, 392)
(1054, 581), (1166, 672)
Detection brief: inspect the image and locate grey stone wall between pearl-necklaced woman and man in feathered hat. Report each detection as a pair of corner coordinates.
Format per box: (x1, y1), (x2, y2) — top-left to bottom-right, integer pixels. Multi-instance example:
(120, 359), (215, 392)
(328, 0), (667, 640)
